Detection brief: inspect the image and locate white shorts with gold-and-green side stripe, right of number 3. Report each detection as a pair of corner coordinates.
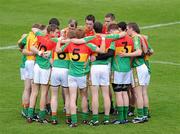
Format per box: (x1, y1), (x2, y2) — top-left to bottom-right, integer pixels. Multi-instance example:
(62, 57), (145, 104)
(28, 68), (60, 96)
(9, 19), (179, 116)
(132, 64), (150, 87)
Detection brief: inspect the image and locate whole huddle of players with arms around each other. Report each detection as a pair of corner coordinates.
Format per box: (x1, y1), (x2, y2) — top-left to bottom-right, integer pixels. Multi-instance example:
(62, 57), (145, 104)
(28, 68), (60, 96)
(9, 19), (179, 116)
(18, 13), (153, 127)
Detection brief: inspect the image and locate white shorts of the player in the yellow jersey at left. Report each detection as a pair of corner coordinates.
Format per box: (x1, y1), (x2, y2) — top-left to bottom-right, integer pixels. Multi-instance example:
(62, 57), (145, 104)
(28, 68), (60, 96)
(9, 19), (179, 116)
(25, 60), (34, 79)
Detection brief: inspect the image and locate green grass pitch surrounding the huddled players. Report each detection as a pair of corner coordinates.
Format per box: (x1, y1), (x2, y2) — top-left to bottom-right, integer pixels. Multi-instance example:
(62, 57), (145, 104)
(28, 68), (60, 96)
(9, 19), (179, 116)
(0, 0), (180, 134)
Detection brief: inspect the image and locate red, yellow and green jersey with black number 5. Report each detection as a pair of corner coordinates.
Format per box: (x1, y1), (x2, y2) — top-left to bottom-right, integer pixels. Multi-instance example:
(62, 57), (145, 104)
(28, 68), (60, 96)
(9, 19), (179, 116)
(61, 43), (97, 77)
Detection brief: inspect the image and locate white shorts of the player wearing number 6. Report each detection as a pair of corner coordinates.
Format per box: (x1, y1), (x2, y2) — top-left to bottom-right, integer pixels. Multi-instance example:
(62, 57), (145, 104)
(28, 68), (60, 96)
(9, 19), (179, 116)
(50, 67), (68, 87)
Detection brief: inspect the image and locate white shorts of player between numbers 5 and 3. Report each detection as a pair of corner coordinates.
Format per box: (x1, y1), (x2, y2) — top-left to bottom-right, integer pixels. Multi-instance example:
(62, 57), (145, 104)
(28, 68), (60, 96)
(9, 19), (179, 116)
(90, 65), (110, 86)
